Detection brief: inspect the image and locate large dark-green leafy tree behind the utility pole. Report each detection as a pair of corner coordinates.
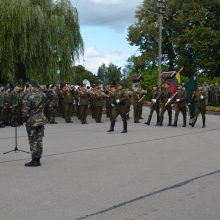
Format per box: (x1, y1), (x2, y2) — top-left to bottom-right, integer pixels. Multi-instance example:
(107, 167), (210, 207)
(128, 0), (220, 76)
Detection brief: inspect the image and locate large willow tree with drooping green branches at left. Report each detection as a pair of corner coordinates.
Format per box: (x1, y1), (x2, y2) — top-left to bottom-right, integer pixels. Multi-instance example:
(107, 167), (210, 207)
(0, 0), (83, 82)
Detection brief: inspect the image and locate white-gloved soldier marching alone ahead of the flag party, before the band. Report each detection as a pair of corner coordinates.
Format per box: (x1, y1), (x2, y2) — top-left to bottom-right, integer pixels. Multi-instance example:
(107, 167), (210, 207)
(108, 84), (128, 133)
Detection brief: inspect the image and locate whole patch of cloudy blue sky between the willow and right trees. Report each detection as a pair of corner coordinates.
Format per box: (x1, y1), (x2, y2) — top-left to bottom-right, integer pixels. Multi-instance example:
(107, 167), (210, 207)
(71, 0), (143, 74)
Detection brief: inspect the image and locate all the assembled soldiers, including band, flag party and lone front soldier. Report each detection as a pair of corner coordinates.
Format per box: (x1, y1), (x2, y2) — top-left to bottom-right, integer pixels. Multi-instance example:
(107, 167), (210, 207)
(0, 80), (210, 167)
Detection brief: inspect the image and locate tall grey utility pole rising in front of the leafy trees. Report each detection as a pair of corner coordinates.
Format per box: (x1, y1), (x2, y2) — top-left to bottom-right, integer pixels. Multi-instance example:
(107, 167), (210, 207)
(157, 0), (165, 85)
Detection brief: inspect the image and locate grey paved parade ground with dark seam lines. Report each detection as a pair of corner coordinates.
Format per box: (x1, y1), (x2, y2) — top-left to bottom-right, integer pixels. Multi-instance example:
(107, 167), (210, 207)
(0, 108), (220, 220)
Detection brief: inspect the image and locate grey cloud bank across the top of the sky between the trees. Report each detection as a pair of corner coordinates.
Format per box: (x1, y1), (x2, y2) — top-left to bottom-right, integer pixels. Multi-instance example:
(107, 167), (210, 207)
(71, 0), (143, 32)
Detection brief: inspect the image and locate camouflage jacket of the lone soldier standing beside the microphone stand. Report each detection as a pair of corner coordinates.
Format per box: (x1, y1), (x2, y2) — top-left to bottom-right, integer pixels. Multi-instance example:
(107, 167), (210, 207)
(22, 91), (47, 127)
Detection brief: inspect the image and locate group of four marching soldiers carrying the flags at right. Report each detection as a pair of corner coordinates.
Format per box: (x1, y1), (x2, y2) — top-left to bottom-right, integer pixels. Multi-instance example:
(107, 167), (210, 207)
(145, 82), (206, 128)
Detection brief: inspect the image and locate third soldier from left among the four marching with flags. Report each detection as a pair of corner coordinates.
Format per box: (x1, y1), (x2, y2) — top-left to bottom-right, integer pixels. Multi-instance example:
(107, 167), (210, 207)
(172, 84), (187, 127)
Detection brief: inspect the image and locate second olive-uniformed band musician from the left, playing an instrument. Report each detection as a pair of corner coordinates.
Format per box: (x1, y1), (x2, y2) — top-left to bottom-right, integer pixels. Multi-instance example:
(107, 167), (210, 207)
(78, 87), (89, 124)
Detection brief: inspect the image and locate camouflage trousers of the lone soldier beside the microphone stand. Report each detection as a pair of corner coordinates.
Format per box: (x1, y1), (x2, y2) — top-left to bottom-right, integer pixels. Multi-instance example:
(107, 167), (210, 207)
(26, 125), (44, 158)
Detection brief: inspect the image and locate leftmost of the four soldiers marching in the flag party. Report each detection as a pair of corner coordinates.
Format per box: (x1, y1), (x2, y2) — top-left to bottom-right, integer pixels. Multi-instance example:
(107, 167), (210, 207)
(145, 86), (160, 125)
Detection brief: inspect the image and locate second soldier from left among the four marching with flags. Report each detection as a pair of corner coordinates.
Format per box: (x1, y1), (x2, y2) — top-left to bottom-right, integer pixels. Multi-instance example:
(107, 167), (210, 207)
(159, 86), (172, 126)
